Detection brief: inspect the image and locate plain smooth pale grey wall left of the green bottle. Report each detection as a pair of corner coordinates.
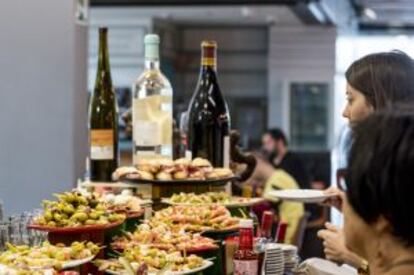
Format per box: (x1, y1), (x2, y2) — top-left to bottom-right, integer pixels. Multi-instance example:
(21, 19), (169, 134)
(0, 0), (87, 214)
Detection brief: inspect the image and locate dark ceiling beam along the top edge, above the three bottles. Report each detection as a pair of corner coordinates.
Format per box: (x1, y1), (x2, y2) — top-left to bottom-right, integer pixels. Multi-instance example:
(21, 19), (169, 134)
(90, 0), (303, 7)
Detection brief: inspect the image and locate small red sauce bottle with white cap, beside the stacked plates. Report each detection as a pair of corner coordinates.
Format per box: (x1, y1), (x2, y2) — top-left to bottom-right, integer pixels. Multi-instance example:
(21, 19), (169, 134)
(233, 219), (259, 275)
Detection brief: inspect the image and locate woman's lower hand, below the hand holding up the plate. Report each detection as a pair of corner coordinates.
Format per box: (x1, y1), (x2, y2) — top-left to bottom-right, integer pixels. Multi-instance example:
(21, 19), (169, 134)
(318, 223), (363, 268)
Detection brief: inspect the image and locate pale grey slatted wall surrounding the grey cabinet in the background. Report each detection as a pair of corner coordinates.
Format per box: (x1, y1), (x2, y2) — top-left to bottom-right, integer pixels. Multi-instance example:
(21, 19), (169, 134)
(268, 25), (336, 149)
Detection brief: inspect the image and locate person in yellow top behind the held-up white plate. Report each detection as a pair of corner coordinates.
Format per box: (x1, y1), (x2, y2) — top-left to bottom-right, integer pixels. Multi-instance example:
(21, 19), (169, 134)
(243, 156), (305, 246)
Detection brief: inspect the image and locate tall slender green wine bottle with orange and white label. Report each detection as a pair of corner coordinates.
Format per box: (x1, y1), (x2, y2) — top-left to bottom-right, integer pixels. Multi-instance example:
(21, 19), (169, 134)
(89, 28), (119, 182)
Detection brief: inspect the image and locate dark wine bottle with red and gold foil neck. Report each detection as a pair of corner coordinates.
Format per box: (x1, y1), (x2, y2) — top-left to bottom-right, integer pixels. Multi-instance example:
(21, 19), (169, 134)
(188, 41), (230, 167)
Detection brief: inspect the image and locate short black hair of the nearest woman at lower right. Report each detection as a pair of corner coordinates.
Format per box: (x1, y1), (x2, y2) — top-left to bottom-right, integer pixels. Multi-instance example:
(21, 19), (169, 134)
(347, 108), (414, 246)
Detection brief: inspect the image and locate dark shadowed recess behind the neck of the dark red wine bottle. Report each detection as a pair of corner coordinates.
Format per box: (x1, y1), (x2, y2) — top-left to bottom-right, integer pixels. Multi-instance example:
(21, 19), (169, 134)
(180, 25), (267, 101)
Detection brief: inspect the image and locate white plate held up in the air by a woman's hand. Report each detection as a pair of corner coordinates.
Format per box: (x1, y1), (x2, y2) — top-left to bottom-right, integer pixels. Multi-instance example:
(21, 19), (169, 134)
(269, 189), (335, 203)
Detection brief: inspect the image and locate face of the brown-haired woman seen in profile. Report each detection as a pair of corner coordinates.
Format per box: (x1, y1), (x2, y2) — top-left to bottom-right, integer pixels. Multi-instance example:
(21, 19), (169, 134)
(342, 83), (374, 126)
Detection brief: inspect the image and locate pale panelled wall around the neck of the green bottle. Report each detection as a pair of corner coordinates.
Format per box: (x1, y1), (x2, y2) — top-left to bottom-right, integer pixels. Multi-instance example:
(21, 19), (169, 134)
(88, 8), (152, 90)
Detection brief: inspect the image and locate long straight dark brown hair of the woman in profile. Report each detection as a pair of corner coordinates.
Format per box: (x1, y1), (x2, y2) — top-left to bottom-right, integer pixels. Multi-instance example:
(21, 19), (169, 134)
(345, 51), (414, 111)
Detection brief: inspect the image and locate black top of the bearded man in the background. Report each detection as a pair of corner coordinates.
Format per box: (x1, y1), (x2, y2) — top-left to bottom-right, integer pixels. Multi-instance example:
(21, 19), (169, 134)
(271, 152), (310, 189)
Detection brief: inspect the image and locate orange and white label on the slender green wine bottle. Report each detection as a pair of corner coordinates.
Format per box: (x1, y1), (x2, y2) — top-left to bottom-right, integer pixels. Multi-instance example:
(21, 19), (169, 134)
(90, 129), (114, 160)
